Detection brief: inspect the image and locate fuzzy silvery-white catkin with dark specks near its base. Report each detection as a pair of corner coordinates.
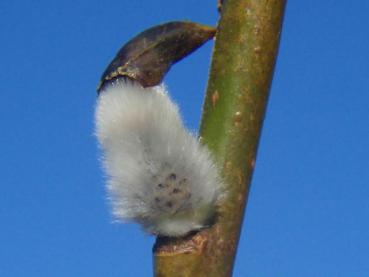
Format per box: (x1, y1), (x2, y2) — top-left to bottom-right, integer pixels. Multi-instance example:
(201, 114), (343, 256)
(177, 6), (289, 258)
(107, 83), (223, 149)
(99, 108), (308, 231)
(95, 79), (221, 237)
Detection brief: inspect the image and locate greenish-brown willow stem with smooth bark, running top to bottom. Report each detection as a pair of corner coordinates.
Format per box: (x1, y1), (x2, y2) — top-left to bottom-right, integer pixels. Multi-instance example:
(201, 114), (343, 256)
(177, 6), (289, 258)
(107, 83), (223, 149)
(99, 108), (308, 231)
(154, 0), (285, 277)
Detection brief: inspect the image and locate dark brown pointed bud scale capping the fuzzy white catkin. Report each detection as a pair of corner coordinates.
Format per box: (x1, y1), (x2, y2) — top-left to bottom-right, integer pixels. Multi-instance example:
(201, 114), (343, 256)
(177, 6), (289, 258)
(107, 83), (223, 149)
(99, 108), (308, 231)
(97, 21), (216, 92)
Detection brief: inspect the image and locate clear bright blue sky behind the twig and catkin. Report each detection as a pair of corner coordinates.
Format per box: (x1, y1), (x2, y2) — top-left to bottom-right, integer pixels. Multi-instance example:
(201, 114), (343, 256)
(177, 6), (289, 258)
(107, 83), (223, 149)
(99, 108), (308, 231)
(0, 0), (369, 277)
